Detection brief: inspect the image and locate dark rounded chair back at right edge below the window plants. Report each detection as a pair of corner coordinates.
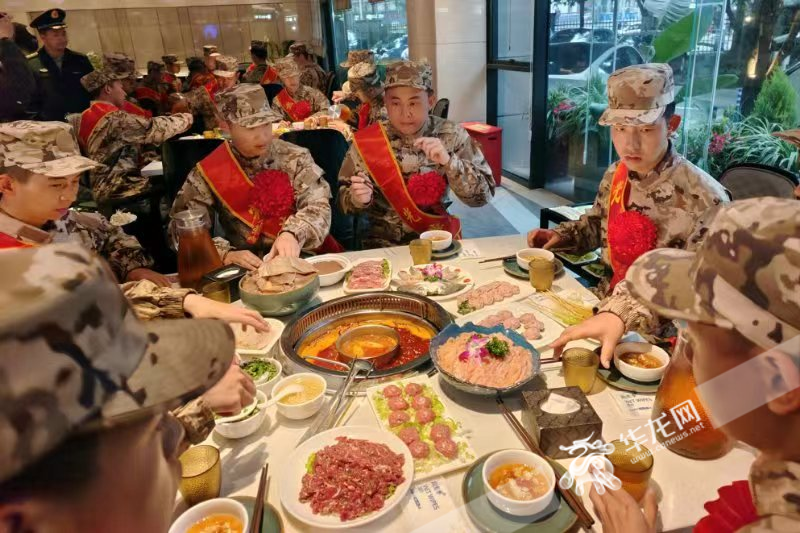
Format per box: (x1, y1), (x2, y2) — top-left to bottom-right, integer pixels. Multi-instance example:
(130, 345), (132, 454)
(719, 163), (798, 200)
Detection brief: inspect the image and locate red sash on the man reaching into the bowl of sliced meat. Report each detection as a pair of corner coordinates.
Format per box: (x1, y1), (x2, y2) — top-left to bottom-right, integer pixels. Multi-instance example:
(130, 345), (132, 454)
(197, 142), (344, 253)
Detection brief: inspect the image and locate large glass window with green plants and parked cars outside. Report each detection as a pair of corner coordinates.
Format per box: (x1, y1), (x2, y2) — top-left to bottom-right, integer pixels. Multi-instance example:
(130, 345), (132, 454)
(488, 0), (800, 201)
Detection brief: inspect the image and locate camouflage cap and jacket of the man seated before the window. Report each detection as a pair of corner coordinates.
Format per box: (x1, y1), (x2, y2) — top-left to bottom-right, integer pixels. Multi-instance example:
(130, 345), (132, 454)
(554, 64), (728, 333)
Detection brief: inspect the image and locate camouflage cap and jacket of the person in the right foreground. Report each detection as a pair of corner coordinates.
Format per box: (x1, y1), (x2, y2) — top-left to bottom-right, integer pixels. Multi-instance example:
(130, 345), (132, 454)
(626, 197), (800, 533)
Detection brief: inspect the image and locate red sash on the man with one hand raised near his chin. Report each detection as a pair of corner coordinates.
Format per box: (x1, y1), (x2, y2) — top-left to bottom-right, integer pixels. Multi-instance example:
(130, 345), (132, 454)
(353, 122), (461, 239)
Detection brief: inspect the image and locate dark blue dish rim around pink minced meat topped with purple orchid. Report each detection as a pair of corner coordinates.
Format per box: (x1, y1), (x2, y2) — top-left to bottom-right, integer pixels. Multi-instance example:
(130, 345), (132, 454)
(430, 322), (540, 396)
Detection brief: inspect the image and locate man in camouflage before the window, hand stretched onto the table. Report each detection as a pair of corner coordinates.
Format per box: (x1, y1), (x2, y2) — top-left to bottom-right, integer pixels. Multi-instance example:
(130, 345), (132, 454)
(544, 64), (728, 366)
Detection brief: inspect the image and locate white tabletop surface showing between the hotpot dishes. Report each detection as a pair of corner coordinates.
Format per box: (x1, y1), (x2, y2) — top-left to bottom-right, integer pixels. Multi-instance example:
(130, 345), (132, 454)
(183, 235), (754, 533)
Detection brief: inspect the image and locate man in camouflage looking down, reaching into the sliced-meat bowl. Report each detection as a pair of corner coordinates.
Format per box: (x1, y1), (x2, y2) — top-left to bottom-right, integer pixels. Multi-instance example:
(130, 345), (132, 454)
(171, 84), (331, 269)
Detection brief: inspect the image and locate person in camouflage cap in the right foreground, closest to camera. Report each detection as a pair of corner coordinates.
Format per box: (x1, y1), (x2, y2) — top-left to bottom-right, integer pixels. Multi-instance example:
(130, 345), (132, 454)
(591, 197), (800, 533)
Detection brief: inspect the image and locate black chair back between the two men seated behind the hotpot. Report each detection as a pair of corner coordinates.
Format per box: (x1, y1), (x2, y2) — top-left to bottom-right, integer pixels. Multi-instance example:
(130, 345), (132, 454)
(281, 129), (356, 250)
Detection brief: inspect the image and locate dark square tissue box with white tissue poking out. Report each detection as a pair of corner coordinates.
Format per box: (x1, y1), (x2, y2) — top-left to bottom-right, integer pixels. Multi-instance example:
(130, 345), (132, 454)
(522, 387), (603, 459)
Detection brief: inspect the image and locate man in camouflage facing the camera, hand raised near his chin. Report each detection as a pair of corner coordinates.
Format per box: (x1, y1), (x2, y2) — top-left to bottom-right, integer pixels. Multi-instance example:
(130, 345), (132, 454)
(338, 61), (494, 248)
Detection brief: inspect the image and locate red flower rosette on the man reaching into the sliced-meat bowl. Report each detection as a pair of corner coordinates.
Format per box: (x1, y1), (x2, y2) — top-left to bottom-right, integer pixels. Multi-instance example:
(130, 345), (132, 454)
(247, 170), (294, 244)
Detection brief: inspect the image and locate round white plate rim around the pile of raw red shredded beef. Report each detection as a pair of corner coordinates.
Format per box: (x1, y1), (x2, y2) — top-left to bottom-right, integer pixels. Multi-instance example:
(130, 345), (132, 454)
(279, 426), (414, 529)
